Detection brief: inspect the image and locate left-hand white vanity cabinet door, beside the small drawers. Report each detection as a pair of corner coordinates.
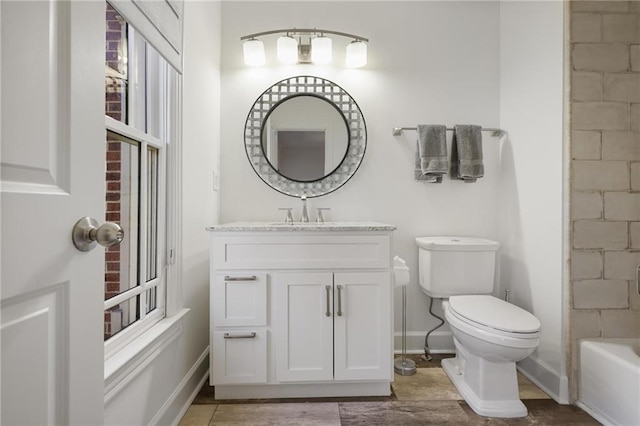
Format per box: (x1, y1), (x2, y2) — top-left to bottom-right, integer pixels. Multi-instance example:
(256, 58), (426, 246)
(273, 272), (333, 382)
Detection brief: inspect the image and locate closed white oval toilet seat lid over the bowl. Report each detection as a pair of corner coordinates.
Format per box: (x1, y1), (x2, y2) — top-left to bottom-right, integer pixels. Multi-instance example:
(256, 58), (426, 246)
(449, 295), (540, 333)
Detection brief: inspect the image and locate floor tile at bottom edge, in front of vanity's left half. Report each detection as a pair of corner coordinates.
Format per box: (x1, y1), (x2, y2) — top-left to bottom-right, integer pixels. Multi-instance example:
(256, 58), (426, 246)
(210, 402), (340, 426)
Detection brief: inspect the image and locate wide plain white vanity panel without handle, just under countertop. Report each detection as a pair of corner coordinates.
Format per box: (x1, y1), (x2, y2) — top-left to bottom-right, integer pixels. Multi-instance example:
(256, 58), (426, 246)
(212, 234), (391, 269)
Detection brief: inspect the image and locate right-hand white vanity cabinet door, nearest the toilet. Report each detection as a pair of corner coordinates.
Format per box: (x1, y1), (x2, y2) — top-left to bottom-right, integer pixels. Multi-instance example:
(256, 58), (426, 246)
(334, 272), (393, 380)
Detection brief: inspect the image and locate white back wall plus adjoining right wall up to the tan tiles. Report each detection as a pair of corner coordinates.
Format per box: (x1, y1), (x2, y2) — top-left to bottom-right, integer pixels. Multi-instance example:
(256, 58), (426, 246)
(220, 1), (564, 399)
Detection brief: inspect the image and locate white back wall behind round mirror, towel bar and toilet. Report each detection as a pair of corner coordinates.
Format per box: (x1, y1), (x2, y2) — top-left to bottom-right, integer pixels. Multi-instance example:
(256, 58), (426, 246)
(220, 2), (500, 350)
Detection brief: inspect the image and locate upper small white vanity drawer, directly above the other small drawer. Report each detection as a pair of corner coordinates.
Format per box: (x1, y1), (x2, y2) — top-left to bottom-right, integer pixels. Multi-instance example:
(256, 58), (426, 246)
(211, 271), (267, 327)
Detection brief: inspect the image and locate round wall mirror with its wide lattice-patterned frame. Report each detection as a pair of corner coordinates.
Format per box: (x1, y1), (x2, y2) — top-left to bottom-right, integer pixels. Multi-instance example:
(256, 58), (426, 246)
(245, 76), (367, 197)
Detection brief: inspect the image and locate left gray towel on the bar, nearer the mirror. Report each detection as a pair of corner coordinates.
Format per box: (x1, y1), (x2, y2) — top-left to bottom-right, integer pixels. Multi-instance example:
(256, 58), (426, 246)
(414, 124), (449, 183)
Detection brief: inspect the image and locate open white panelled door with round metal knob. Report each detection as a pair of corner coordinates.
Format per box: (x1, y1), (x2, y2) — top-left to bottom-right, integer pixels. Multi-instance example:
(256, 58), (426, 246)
(0, 1), (105, 425)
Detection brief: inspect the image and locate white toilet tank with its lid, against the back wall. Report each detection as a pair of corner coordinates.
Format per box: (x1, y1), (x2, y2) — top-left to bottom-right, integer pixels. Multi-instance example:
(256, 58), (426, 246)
(416, 237), (500, 298)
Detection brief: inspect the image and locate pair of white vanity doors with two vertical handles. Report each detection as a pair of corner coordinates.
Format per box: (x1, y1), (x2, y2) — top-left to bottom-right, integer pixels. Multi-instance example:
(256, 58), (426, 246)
(273, 272), (391, 382)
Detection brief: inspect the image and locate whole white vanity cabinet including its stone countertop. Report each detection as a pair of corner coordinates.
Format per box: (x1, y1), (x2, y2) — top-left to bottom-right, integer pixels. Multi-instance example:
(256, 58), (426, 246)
(209, 223), (394, 399)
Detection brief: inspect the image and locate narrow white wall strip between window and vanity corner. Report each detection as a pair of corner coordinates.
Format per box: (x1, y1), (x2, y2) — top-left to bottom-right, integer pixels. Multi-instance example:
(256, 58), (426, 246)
(182, 1), (222, 390)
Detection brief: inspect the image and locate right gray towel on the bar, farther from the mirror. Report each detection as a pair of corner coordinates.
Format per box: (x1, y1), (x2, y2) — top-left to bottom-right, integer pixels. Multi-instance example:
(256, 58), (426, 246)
(451, 124), (484, 182)
